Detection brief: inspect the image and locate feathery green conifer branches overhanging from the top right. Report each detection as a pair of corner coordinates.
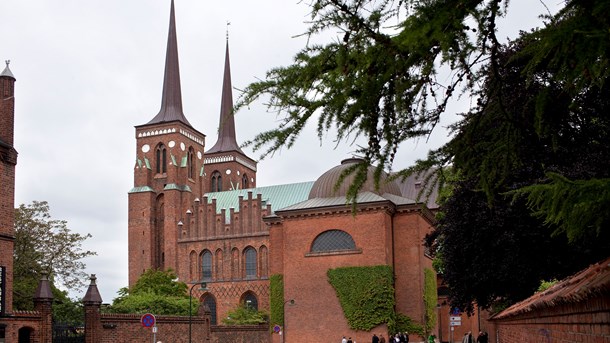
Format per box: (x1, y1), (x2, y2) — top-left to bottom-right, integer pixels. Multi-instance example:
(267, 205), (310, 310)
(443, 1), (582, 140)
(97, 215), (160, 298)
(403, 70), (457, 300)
(237, 0), (610, 236)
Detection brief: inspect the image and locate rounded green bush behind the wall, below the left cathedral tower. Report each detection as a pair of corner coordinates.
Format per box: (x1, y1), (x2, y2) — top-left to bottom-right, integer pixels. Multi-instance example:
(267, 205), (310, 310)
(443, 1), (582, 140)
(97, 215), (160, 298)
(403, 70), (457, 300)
(107, 269), (199, 316)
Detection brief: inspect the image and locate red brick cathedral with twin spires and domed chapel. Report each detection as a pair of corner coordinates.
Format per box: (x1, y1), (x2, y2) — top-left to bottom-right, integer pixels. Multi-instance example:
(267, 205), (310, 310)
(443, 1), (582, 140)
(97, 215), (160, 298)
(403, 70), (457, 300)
(128, 1), (435, 342)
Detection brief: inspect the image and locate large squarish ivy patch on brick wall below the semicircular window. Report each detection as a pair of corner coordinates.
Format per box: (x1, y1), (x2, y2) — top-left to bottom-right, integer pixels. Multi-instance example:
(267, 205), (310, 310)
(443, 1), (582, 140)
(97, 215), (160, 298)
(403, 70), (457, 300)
(327, 266), (396, 331)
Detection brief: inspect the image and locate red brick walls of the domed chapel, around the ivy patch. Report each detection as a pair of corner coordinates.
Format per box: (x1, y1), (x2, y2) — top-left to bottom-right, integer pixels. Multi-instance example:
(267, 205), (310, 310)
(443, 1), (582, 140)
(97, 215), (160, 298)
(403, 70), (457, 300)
(269, 201), (431, 342)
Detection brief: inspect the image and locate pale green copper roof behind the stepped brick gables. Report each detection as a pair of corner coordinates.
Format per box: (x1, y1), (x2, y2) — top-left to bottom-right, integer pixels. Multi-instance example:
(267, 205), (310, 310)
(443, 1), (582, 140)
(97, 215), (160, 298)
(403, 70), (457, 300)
(205, 181), (313, 213)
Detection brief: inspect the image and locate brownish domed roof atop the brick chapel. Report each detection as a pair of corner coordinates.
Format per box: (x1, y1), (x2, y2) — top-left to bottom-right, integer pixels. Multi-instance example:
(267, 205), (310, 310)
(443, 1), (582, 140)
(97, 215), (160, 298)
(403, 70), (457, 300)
(309, 158), (402, 199)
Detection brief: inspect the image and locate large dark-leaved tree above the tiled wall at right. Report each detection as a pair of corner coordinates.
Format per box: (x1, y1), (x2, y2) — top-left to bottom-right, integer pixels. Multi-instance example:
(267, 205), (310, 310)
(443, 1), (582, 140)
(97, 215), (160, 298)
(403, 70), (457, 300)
(428, 34), (610, 310)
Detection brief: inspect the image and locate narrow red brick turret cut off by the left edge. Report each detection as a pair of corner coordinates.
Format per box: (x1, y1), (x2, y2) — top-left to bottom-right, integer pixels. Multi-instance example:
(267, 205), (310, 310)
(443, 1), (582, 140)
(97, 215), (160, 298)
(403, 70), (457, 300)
(0, 61), (17, 314)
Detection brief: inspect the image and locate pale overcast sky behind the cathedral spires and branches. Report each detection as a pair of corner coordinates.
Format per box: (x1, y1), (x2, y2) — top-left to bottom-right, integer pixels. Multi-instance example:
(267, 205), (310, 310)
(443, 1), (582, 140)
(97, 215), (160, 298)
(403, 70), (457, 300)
(0, 0), (562, 303)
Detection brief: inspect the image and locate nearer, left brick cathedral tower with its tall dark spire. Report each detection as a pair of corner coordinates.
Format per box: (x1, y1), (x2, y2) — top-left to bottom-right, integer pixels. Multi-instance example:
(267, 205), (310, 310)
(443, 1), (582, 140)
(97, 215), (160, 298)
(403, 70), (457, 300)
(128, 0), (205, 285)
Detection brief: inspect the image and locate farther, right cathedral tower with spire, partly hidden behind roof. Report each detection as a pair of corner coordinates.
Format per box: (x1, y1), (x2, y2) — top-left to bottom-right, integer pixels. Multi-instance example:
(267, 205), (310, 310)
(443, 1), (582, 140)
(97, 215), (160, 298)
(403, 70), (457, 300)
(204, 39), (256, 192)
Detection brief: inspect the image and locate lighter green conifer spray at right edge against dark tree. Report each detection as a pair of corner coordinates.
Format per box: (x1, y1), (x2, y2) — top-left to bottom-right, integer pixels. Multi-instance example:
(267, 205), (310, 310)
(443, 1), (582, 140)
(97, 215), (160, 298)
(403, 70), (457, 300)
(514, 173), (610, 242)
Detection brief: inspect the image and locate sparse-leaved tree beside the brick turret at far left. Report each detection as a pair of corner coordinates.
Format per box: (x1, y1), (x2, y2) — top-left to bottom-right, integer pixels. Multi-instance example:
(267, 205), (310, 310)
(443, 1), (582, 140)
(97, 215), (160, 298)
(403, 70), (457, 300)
(13, 201), (96, 310)
